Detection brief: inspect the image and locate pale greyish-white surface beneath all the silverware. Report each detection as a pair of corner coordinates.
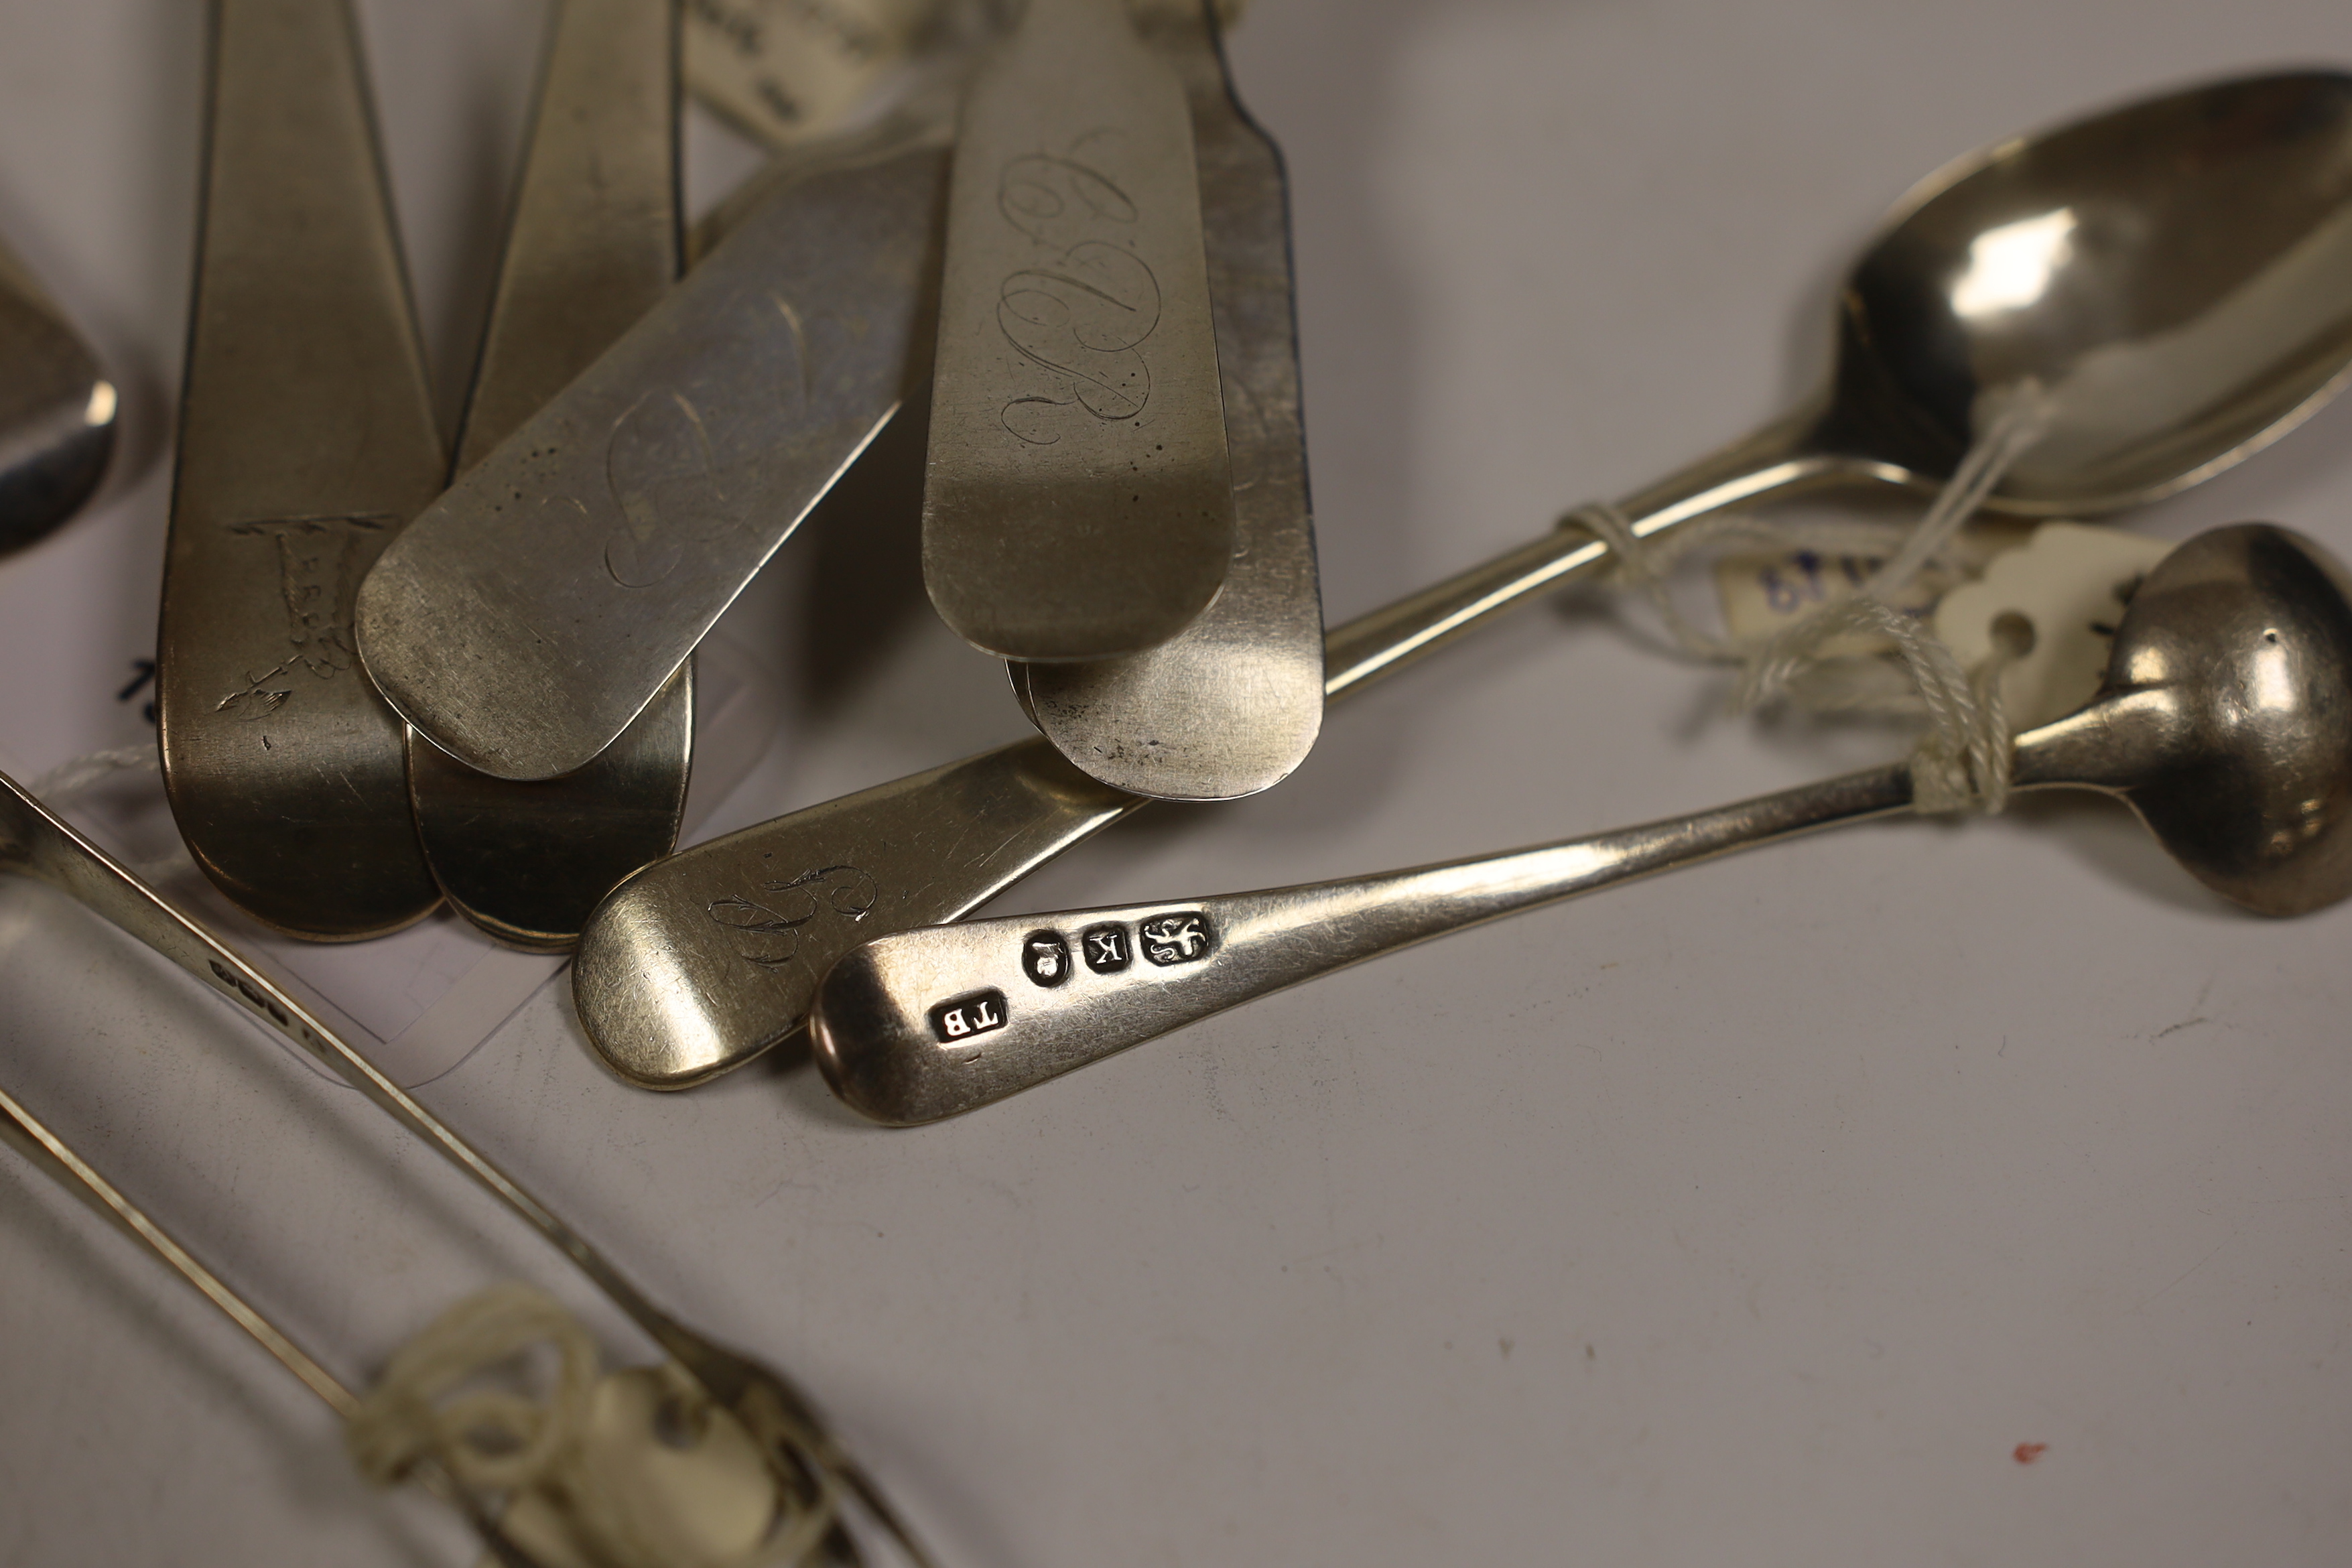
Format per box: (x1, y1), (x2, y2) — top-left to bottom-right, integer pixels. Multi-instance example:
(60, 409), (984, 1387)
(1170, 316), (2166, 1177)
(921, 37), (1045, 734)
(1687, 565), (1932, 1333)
(0, 0), (2352, 1568)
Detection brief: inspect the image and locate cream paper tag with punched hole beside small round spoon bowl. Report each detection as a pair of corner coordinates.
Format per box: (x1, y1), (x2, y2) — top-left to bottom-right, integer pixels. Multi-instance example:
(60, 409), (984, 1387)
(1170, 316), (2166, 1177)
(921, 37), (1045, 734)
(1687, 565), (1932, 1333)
(1936, 522), (2173, 729)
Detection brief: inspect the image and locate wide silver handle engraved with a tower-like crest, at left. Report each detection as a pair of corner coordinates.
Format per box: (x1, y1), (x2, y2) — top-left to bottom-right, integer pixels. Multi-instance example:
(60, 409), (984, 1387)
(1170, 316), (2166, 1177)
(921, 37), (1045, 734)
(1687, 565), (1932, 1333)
(155, 0), (447, 940)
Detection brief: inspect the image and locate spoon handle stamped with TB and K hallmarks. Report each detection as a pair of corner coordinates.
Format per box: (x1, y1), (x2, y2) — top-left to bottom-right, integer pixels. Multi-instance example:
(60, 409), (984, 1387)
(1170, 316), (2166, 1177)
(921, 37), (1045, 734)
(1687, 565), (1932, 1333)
(809, 764), (1912, 1126)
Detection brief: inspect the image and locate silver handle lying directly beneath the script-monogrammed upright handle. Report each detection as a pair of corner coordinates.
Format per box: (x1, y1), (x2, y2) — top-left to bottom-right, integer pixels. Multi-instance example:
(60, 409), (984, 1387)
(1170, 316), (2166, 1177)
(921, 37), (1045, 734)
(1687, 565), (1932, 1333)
(1011, 5), (1324, 799)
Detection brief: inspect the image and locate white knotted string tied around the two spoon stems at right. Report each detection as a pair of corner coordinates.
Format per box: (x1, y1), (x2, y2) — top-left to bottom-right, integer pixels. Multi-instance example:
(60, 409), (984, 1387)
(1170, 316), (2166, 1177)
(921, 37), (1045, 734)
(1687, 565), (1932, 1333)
(1564, 385), (2048, 813)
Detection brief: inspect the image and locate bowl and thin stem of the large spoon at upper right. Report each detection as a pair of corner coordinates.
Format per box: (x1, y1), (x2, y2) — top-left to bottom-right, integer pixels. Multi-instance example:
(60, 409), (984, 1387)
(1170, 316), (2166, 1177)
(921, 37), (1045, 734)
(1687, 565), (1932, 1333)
(1327, 70), (2352, 681)
